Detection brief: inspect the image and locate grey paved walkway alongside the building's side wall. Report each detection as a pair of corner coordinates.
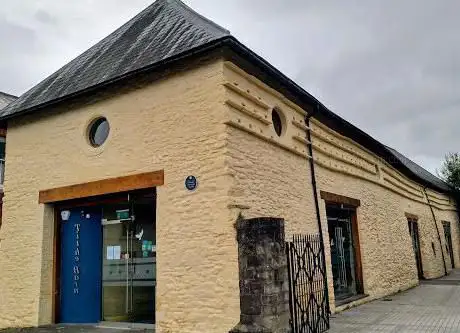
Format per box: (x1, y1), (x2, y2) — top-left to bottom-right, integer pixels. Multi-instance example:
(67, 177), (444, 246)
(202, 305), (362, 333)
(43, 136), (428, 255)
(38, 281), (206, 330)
(328, 269), (460, 333)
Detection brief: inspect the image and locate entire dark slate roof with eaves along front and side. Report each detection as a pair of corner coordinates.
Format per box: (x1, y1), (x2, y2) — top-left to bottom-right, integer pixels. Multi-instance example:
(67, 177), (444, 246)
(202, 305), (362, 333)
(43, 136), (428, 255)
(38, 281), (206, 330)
(0, 0), (450, 192)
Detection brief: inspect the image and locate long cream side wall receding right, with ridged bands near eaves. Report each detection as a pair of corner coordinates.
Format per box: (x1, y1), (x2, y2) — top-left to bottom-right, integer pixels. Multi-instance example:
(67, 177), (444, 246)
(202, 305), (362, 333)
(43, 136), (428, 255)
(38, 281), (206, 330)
(224, 62), (460, 310)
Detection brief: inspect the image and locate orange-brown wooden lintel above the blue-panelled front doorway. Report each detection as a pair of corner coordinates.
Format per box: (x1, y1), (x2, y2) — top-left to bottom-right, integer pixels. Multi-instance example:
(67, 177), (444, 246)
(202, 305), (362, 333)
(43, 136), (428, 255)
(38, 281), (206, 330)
(38, 170), (164, 203)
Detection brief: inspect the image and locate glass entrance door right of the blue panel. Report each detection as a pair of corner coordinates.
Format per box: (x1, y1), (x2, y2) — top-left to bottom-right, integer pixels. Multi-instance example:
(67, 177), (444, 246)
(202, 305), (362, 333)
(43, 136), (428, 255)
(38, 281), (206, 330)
(102, 191), (156, 324)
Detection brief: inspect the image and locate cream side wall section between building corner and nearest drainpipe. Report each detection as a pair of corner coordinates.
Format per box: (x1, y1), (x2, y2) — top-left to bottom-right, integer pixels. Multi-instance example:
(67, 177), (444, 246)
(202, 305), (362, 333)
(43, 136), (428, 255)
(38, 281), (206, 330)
(225, 63), (318, 233)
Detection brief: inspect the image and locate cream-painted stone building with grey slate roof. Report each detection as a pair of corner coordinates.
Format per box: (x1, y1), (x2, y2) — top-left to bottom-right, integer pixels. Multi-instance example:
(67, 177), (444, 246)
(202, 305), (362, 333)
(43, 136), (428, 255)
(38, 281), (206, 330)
(0, 0), (460, 332)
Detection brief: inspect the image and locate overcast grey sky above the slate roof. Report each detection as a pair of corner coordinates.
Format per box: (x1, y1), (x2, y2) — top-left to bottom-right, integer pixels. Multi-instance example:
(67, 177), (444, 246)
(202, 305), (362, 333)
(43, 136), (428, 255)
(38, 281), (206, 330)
(0, 0), (460, 172)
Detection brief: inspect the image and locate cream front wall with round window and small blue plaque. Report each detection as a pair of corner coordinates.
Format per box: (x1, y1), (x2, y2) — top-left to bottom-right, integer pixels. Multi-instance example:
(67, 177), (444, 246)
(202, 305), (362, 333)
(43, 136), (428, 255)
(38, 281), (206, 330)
(0, 61), (239, 333)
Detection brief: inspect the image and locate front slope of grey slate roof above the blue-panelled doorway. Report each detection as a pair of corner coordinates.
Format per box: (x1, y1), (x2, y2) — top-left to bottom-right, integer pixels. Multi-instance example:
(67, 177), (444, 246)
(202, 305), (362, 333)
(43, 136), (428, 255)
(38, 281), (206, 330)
(0, 0), (230, 118)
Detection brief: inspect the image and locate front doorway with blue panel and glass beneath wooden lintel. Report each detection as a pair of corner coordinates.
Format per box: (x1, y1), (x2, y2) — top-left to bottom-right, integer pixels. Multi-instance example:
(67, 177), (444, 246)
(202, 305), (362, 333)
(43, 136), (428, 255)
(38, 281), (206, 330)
(56, 188), (156, 324)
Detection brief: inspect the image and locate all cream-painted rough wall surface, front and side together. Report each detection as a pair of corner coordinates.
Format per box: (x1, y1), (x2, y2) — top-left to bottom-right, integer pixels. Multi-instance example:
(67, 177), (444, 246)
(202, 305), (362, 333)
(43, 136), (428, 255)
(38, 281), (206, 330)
(0, 55), (460, 332)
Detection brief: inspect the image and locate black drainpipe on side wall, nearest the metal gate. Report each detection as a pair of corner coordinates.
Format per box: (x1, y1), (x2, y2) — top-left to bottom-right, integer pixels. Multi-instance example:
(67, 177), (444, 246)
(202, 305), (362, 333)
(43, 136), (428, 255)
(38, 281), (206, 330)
(305, 104), (331, 313)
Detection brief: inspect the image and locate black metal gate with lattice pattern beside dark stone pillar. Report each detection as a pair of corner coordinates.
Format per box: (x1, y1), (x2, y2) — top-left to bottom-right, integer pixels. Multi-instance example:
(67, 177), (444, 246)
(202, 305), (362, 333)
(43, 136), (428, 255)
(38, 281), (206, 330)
(286, 235), (329, 333)
